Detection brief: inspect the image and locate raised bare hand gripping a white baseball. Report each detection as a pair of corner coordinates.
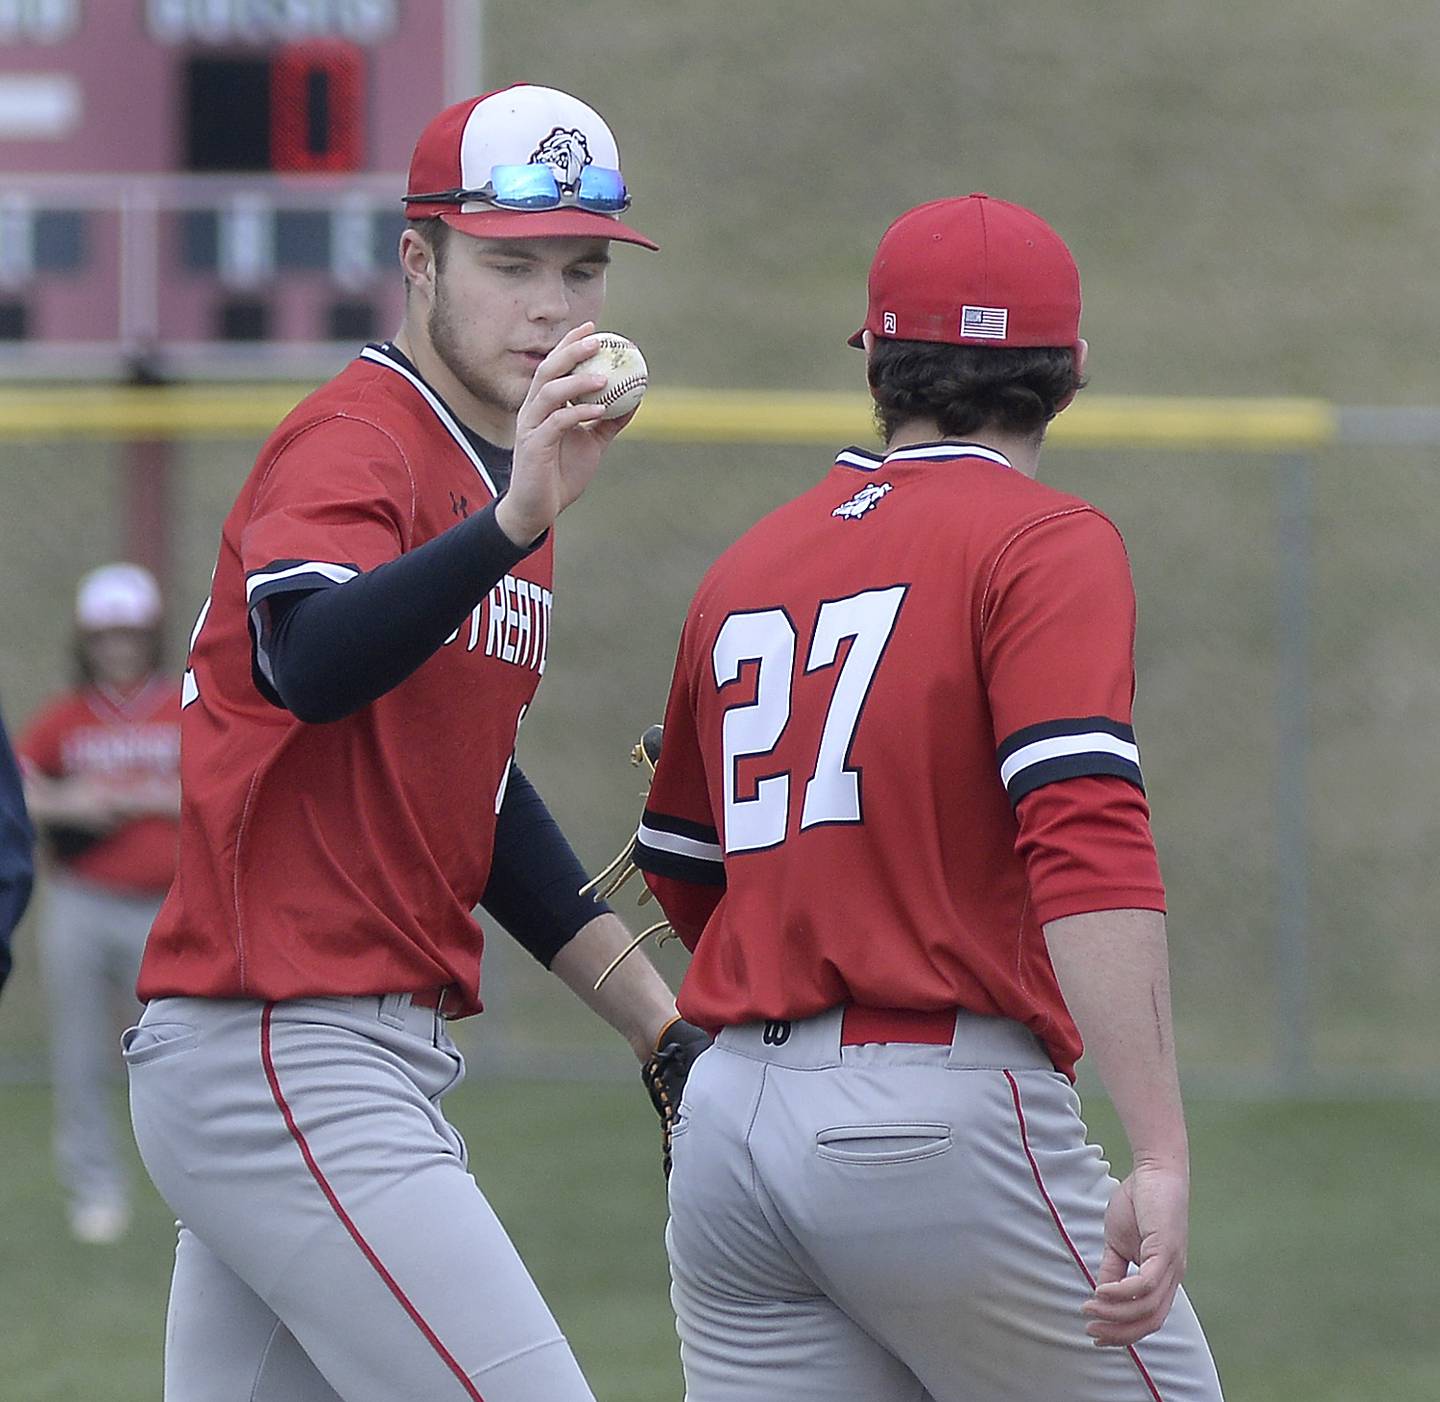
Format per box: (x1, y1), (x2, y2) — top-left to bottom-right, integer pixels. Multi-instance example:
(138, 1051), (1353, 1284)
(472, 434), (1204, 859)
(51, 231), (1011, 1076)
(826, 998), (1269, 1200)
(495, 321), (648, 546)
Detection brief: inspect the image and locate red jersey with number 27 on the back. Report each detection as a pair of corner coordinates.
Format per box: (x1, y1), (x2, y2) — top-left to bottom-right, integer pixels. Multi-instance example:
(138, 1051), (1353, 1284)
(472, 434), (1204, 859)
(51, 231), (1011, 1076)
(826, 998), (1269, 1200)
(636, 443), (1164, 1074)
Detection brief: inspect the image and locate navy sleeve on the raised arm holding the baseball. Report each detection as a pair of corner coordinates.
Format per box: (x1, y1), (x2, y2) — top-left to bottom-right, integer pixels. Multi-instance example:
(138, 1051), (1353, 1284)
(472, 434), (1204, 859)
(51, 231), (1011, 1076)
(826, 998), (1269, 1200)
(260, 502), (544, 724)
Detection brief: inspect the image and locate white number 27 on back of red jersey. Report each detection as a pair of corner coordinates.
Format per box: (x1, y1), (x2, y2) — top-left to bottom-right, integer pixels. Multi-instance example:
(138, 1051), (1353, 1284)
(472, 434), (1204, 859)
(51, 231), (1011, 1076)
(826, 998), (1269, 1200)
(711, 584), (907, 852)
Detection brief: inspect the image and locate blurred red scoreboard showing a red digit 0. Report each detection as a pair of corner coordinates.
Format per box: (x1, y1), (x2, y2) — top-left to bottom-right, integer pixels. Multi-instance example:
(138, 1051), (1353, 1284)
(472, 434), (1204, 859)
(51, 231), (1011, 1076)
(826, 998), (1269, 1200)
(0, 0), (481, 377)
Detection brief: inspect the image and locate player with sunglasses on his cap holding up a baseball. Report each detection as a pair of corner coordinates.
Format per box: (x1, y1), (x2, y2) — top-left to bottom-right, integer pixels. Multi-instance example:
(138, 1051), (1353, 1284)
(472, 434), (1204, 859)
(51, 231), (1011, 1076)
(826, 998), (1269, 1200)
(127, 85), (696, 1402)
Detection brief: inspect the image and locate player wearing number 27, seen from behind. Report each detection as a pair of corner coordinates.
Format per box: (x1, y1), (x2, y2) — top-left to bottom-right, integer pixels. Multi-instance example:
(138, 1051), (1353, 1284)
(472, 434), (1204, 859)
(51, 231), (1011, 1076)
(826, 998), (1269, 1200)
(636, 194), (1220, 1402)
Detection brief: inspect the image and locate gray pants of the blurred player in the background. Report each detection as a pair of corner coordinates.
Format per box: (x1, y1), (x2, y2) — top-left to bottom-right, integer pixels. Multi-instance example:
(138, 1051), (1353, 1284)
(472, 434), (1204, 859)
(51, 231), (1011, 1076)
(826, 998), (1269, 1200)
(39, 872), (163, 1208)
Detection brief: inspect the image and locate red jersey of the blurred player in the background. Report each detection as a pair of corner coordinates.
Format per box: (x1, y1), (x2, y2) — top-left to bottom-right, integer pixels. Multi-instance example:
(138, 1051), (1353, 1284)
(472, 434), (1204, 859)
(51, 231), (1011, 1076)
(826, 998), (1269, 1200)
(16, 677), (180, 894)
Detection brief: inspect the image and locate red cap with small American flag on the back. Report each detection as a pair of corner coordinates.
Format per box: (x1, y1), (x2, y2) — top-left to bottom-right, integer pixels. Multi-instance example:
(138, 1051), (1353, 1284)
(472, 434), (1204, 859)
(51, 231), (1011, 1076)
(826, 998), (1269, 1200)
(850, 193), (1080, 345)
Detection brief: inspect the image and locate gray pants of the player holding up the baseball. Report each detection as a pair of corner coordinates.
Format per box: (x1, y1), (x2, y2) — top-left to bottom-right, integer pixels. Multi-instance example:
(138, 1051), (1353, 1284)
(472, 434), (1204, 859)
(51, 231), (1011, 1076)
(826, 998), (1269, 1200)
(125, 993), (593, 1402)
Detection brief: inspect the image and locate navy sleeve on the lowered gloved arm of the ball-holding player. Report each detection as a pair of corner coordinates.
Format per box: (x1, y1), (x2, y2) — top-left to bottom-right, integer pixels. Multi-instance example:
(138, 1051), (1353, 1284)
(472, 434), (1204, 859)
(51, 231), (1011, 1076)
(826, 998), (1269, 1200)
(481, 764), (611, 969)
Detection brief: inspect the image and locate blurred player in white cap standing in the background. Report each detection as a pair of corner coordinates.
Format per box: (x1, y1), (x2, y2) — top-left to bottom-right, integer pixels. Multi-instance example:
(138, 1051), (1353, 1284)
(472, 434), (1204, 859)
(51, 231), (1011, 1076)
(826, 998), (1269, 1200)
(16, 564), (180, 1244)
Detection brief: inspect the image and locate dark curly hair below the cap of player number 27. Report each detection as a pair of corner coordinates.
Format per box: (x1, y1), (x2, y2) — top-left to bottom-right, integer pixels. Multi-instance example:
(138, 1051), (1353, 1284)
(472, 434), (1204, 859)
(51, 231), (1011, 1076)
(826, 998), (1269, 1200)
(868, 337), (1084, 442)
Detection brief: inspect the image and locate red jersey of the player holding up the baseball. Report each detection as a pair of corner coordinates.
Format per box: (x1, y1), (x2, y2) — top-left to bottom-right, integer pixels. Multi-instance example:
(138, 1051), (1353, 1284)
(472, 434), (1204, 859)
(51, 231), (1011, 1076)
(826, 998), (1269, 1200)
(138, 347), (553, 1013)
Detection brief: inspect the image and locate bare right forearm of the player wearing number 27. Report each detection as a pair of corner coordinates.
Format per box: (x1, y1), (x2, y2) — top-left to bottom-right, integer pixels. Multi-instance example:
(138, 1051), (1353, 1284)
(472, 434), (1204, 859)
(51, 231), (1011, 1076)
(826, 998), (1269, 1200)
(1045, 910), (1188, 1169)
